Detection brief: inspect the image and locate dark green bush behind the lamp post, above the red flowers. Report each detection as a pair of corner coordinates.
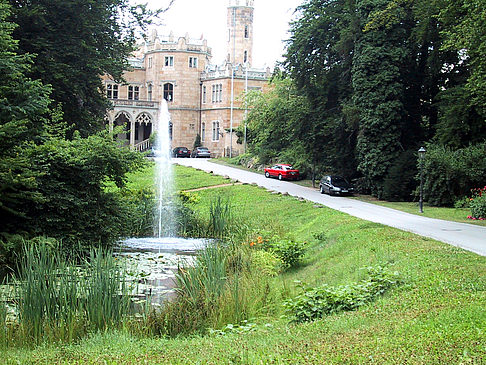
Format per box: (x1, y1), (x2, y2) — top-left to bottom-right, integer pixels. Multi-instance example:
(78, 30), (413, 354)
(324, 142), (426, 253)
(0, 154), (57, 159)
(423, 142), (486, 206)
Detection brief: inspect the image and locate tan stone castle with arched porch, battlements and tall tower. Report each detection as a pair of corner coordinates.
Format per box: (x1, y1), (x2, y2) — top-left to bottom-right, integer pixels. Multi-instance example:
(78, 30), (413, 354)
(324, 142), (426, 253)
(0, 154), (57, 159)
(103, 0), (270, 156)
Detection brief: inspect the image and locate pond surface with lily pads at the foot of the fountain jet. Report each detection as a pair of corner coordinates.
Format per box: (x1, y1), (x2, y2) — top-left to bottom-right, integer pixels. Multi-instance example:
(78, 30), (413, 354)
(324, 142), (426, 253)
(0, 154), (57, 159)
(116, 237), (207, 306)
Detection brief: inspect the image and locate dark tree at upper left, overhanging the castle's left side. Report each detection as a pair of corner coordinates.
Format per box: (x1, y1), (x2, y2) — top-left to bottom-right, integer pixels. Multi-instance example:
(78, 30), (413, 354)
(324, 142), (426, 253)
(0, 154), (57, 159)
(10, 0), (173, 136)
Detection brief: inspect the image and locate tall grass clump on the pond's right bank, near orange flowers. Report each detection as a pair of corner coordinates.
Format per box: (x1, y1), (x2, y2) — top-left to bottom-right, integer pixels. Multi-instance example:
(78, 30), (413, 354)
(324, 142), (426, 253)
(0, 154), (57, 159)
(148, 242), (274, 336)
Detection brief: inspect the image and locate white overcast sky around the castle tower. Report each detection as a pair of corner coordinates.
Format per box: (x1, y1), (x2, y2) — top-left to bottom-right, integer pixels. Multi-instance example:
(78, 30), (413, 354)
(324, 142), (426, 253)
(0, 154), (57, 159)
(145, 0), (303, 68)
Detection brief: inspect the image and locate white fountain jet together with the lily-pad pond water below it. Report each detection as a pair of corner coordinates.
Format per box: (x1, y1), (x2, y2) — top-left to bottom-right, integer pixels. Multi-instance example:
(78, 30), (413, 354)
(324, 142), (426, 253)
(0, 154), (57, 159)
(118, 100), (206, 305)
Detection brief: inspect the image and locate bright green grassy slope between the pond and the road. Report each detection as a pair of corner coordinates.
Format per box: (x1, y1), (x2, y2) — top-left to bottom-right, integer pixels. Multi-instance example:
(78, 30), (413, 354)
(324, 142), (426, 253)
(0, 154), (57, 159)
(4, 168), (486, 364)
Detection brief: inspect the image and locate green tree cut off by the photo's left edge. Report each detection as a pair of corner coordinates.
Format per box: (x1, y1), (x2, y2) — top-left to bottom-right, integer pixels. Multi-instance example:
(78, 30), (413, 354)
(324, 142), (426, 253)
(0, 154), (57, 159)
(0, 0), (50, 233)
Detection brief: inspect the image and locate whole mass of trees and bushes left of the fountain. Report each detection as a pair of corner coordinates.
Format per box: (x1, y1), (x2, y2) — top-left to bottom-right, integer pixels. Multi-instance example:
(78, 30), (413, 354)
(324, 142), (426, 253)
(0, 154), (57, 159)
(0, 0), (167, 264)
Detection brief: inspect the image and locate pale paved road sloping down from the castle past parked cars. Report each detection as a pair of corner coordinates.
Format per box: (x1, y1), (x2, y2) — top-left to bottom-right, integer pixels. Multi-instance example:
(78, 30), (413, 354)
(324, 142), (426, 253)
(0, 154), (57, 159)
(173, 158), (486, 256)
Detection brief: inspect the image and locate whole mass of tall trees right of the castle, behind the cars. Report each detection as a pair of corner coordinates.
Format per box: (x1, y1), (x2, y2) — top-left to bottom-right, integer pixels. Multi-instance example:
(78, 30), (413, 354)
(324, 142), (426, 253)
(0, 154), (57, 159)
(243, 0), (486, 200)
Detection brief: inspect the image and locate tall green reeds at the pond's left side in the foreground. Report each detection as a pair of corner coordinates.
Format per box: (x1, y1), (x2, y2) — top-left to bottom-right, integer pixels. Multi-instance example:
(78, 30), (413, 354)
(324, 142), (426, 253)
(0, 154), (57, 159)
(15, 245), (135, 343)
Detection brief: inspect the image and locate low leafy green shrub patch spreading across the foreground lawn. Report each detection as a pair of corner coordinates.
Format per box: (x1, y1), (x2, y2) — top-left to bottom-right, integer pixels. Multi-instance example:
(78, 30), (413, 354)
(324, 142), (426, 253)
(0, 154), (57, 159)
(284, 266), (399, 322)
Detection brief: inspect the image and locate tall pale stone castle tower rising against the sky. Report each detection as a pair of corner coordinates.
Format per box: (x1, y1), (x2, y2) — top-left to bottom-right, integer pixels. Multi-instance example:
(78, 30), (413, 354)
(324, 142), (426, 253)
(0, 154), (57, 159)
(226, 0), (253, 66)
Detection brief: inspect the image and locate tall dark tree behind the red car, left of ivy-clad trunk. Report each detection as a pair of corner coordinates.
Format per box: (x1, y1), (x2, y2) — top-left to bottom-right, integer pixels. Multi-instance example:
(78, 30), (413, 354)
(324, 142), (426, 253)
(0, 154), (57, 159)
(284, 0), (359, 176)
